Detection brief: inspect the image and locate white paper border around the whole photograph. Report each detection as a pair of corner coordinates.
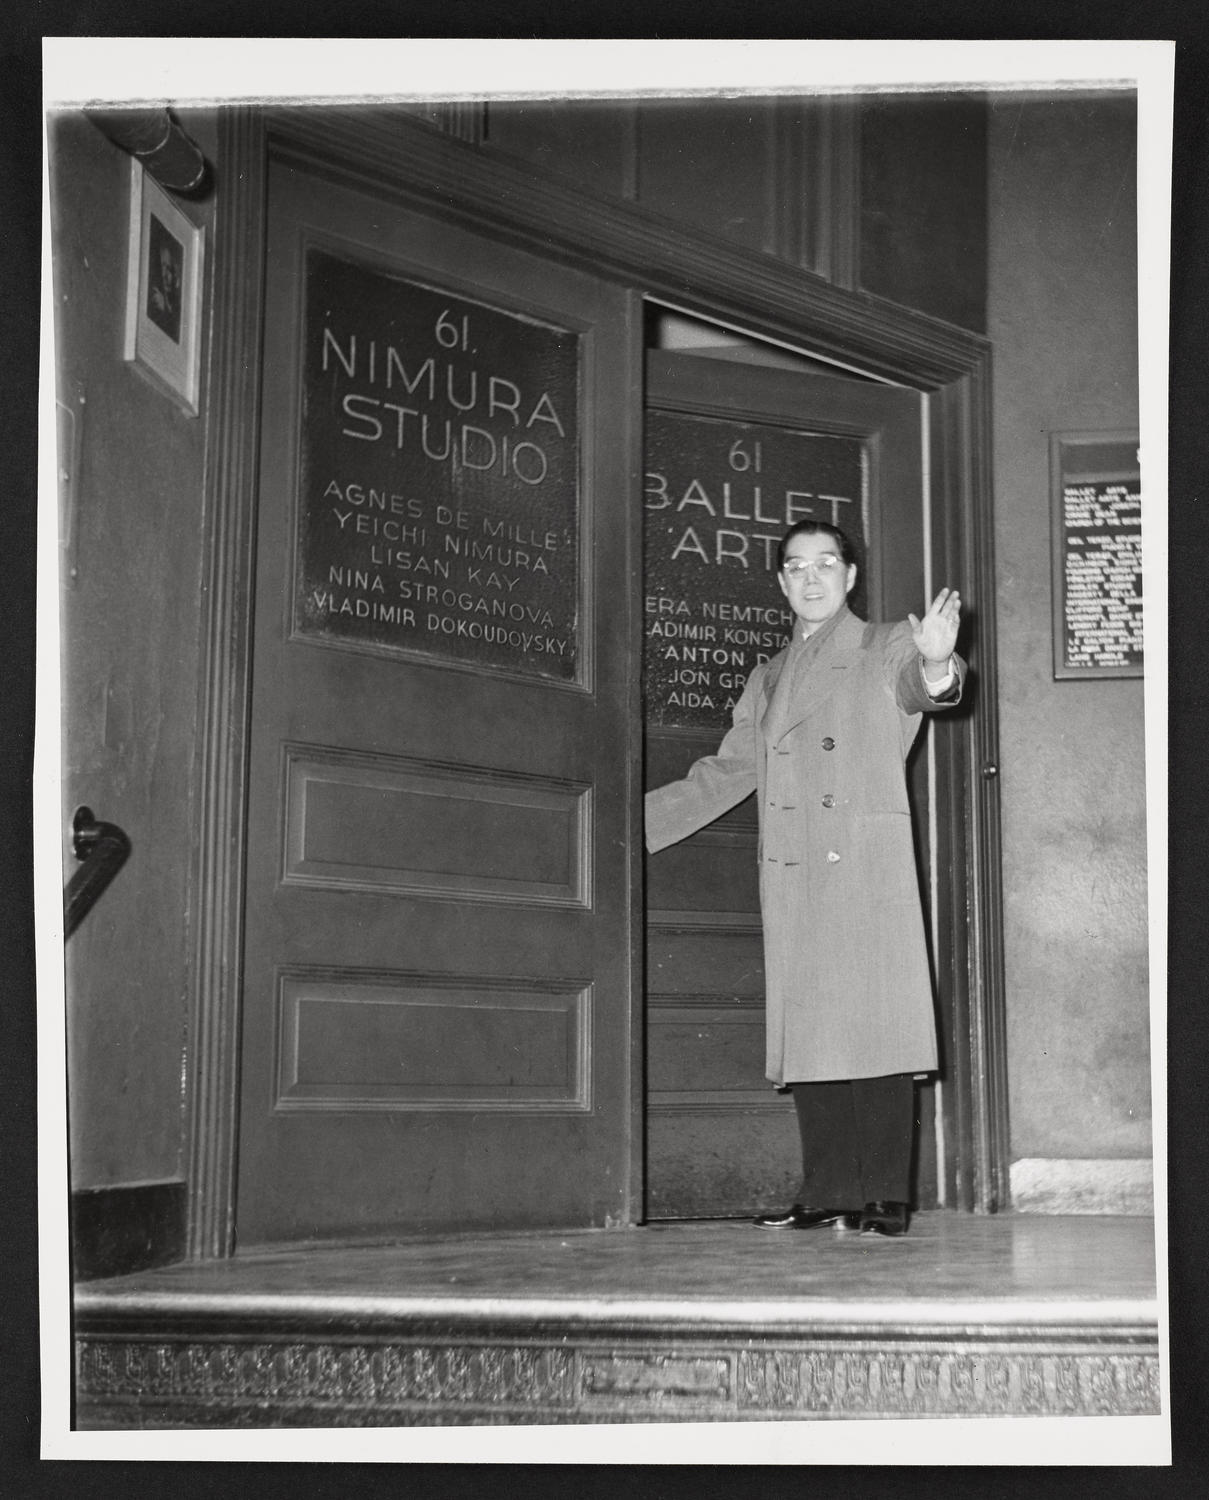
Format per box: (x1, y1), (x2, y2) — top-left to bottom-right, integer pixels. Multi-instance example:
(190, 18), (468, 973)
(33, 36), (1176, 1464)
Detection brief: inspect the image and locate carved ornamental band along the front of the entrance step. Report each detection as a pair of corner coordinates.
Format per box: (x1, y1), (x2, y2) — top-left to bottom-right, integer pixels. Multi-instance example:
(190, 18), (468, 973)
(77, 1331), (1160, 1428)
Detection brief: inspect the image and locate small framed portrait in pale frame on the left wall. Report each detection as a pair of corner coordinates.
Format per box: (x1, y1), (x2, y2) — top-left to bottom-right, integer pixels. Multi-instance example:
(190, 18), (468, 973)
(123, 162), (206, 416)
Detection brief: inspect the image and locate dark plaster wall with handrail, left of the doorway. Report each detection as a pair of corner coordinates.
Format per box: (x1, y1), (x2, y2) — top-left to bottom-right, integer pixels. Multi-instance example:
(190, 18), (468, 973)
(52, 114), (213, 1190)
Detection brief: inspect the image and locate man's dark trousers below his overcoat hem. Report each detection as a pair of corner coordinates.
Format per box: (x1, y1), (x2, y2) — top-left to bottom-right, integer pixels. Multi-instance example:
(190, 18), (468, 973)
(791, 1073), (915, 1209)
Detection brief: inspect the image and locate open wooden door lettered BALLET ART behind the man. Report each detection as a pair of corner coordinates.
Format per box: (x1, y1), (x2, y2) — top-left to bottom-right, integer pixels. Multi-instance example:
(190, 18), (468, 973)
(644, 354), (950, 1218)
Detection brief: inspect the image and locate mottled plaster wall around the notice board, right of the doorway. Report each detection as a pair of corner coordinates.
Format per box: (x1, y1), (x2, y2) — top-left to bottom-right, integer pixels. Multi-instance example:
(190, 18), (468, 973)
(989, 98), (1151, 1170)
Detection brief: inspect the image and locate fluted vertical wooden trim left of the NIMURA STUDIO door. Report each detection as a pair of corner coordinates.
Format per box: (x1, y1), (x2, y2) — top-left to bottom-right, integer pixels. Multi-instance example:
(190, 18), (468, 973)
(186, 108), (267, 1260)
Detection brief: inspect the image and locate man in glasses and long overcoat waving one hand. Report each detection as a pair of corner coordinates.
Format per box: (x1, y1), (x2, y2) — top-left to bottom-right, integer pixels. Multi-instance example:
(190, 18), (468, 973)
(647, 521), (966, 1235)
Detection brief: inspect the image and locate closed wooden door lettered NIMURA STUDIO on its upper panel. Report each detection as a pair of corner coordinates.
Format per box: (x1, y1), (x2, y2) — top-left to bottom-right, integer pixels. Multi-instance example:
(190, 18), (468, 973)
(237, 161), (639, 1248)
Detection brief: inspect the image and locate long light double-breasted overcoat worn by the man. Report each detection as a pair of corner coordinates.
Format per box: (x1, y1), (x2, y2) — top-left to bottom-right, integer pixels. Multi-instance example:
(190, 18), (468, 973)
(647, 608), (966, 1085)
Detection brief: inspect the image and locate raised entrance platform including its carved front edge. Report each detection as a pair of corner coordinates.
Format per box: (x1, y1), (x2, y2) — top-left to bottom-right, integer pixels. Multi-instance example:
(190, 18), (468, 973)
(75, 1212), (1160, 1428)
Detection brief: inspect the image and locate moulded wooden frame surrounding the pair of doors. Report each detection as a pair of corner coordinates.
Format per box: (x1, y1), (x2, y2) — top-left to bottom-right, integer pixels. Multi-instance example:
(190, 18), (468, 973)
(188, 105), (1008, 1259)
